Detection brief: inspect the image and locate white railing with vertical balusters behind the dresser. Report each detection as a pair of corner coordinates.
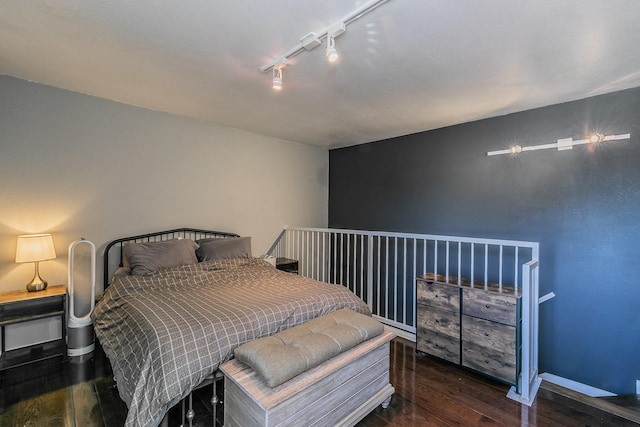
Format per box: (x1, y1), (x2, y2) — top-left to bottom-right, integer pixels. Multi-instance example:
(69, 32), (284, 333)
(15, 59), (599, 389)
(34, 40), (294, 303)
(268, 228), (539, 404)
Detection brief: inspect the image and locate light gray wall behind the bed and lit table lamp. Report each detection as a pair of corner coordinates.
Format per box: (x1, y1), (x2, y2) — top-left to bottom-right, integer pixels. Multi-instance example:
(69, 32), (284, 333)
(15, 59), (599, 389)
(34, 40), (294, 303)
(0, 76), (328, 298)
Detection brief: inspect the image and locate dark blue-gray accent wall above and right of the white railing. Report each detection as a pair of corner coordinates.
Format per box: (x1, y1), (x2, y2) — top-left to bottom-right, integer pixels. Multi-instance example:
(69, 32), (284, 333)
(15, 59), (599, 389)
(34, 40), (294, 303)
(329, 88), (640, 394)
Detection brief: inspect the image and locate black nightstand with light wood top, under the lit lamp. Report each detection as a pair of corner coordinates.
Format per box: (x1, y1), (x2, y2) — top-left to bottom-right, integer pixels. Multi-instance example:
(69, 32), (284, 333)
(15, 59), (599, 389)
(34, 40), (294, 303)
(0, 285), (67, 371)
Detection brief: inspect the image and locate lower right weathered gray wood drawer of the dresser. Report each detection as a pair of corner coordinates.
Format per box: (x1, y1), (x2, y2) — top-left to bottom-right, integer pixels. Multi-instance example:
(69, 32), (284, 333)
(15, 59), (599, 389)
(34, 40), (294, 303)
(462, 315), (518, 384)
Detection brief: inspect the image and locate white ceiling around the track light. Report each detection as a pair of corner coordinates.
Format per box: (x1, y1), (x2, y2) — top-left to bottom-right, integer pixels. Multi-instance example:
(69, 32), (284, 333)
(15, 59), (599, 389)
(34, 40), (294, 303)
(0, 0), (640, 148)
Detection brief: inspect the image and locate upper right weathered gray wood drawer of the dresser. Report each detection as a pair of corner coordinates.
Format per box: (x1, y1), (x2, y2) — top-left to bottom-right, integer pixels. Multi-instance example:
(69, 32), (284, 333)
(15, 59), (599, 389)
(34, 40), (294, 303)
(462, 289), (520, 326)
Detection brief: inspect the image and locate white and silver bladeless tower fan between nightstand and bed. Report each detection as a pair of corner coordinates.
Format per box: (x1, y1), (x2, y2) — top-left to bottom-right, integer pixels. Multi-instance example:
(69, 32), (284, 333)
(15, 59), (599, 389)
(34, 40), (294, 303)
(67, 238), (96, 356)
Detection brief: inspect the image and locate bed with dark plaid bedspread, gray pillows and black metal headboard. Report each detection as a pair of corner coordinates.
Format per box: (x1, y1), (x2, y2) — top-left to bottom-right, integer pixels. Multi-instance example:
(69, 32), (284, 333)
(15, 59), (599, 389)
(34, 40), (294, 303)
(92, 228), (370, 427)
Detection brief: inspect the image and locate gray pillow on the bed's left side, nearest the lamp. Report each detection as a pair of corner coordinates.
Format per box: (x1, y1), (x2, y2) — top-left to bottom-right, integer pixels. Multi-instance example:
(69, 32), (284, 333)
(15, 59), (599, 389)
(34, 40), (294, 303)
(124, 239), (198, 275)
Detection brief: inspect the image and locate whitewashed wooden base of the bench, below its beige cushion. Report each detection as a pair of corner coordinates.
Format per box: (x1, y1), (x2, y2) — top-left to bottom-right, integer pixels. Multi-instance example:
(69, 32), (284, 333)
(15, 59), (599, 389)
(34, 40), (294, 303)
(220, 332), (395, 427)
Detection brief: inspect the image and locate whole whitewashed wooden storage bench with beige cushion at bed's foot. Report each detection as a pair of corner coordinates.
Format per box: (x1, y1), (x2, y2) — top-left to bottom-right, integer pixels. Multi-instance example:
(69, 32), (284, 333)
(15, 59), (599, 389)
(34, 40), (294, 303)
(220, 309), (394, 427)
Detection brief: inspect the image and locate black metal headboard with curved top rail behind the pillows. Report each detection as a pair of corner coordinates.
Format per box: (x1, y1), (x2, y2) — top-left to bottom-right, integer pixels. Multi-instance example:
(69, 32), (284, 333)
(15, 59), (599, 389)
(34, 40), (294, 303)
(102, 228), (240, 290)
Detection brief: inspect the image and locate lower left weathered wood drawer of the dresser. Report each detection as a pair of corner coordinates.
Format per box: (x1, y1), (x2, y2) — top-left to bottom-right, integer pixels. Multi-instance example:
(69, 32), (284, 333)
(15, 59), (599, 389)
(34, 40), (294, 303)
(416, 305), (460, 363)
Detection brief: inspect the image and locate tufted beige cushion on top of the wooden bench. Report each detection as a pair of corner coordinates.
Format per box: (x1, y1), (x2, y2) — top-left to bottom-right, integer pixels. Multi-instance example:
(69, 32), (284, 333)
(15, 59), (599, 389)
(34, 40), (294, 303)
(234, 309), (384, 387)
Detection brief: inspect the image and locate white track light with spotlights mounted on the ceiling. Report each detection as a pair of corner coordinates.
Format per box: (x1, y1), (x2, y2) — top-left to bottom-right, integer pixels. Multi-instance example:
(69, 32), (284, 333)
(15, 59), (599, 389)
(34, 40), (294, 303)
(260, 0), (389, 89)
